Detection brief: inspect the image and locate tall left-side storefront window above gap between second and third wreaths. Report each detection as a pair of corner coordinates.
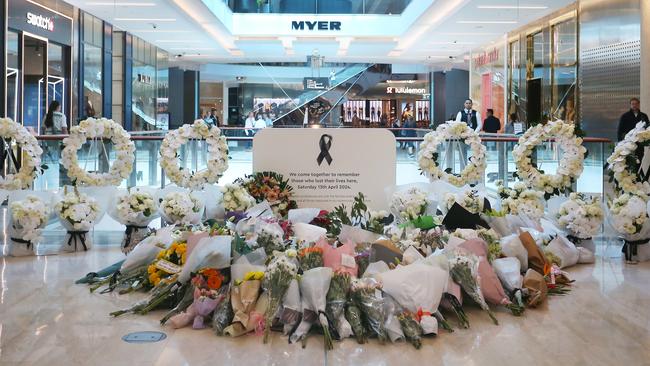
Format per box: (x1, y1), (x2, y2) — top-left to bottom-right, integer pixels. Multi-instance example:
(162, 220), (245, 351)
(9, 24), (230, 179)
(131, 37), (157, 131)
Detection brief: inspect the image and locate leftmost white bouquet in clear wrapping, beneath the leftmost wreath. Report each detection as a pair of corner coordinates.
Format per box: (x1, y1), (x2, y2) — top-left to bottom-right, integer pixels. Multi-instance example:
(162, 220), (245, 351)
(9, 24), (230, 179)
(7, 191), (52, 256)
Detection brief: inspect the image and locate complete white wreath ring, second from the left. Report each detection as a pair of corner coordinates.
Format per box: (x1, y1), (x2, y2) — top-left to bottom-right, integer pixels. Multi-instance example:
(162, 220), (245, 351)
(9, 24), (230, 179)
(61, 118), (135, 186)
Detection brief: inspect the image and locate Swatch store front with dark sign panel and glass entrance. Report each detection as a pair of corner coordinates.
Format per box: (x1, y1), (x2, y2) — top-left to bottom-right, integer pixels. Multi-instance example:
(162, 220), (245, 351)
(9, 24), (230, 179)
(4, 0), (72, 132)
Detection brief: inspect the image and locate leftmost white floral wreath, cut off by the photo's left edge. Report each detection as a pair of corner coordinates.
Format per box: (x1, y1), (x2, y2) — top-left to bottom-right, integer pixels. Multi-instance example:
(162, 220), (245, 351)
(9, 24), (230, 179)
(0, 118), (43, 190)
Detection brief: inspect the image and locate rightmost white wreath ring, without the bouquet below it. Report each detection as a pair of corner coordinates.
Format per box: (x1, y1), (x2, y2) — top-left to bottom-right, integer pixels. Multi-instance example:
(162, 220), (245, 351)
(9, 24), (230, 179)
(607, 122), (650, 196)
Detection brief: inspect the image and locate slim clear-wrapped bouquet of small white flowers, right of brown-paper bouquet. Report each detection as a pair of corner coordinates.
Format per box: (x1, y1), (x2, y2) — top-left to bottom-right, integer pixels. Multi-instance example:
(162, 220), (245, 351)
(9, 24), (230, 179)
(262, 253), (298, 343)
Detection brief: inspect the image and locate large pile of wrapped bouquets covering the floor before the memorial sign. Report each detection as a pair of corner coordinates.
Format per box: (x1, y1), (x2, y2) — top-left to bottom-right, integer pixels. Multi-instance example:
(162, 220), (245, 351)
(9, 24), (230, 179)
(74, 172), (602, 349)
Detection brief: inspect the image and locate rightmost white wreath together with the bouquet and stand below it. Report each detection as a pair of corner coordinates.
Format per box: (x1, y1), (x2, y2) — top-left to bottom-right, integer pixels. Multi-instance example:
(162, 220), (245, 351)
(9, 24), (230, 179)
(607, 122), (650, 261)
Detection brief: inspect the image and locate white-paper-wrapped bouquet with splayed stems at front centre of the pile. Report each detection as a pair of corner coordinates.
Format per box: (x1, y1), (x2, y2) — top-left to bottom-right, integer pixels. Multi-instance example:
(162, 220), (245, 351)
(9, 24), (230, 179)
(289, 267), (333, 349)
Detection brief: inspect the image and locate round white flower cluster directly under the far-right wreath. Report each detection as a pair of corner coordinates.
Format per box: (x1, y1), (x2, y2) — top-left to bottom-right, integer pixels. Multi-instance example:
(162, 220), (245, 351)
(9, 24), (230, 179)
(609, 193), (648, 236)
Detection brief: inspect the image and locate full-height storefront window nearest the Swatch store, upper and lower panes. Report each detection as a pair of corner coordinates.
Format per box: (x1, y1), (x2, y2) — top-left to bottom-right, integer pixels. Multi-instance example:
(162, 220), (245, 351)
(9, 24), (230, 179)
(82, 13), (103, 117)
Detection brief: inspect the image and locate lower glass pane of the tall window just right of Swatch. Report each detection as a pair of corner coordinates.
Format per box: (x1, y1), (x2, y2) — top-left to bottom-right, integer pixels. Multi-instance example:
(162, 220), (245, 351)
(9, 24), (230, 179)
(83, 44), (102, 117)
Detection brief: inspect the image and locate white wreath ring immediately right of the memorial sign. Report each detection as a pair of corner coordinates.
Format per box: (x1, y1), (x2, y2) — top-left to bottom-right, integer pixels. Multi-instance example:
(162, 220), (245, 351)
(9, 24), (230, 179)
(418, 122), (487, 187)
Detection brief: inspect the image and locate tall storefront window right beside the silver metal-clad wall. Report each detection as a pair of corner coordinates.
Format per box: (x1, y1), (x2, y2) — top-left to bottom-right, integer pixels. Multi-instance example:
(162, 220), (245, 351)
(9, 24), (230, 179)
(552, 19), (578, 122)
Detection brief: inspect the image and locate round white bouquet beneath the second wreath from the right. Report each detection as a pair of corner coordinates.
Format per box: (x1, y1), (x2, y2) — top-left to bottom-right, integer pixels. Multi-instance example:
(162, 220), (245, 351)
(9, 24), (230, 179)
(557, 193), (605, 239)
